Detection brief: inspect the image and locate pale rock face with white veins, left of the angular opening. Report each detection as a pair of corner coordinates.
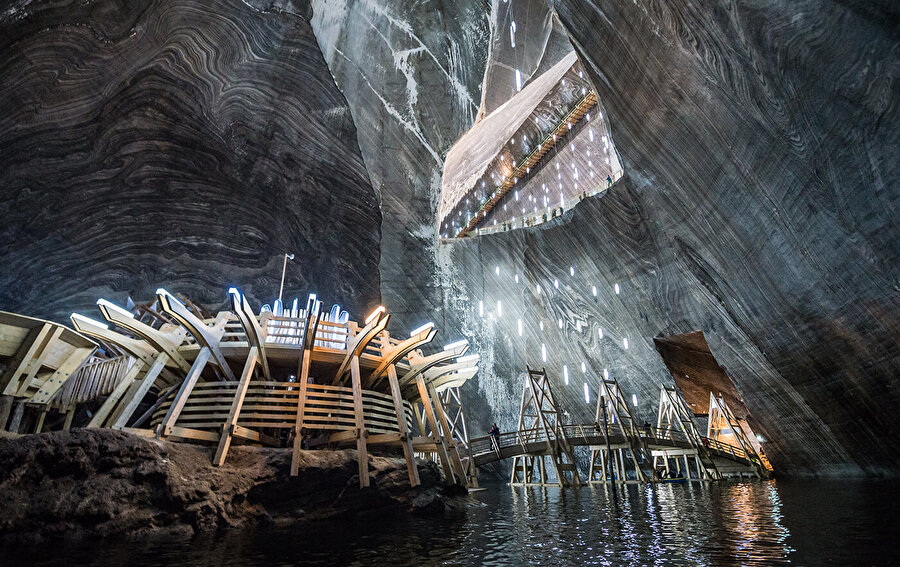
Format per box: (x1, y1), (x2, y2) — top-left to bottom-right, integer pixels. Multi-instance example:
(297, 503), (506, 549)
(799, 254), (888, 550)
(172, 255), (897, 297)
(311, 0), (490, 330)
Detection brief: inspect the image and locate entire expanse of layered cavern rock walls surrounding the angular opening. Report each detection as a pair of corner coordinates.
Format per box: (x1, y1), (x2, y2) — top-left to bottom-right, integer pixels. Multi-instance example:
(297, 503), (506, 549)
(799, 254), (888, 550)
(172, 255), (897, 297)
(0, 0), (900, 475)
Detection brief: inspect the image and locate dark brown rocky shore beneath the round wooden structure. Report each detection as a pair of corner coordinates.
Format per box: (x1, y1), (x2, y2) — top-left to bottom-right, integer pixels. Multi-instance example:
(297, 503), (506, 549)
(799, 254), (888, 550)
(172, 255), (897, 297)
(0, 429), (464, 541)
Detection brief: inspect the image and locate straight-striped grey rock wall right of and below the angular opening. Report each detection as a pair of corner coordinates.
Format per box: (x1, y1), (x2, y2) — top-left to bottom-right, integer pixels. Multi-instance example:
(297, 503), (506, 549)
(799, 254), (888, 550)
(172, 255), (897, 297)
(432, 0), (900, 476)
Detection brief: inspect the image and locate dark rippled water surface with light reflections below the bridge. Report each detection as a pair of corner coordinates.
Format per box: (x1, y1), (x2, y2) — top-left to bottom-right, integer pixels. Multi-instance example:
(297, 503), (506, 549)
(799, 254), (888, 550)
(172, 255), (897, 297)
(0, 480), (900, 567)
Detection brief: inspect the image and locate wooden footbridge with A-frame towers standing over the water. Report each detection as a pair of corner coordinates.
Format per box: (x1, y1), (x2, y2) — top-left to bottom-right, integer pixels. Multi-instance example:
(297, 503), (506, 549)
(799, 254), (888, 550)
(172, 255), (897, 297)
(468, 369), (771, 486)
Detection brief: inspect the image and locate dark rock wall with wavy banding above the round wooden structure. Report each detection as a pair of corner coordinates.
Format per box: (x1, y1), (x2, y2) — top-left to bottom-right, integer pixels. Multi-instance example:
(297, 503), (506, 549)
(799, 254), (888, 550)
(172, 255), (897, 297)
(0, 0), (381, 320)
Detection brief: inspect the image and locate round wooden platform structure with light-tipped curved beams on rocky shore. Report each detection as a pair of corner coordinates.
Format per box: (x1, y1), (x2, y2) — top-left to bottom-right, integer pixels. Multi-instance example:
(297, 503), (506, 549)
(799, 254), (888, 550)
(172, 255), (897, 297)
(0, 288), (478, 487)
